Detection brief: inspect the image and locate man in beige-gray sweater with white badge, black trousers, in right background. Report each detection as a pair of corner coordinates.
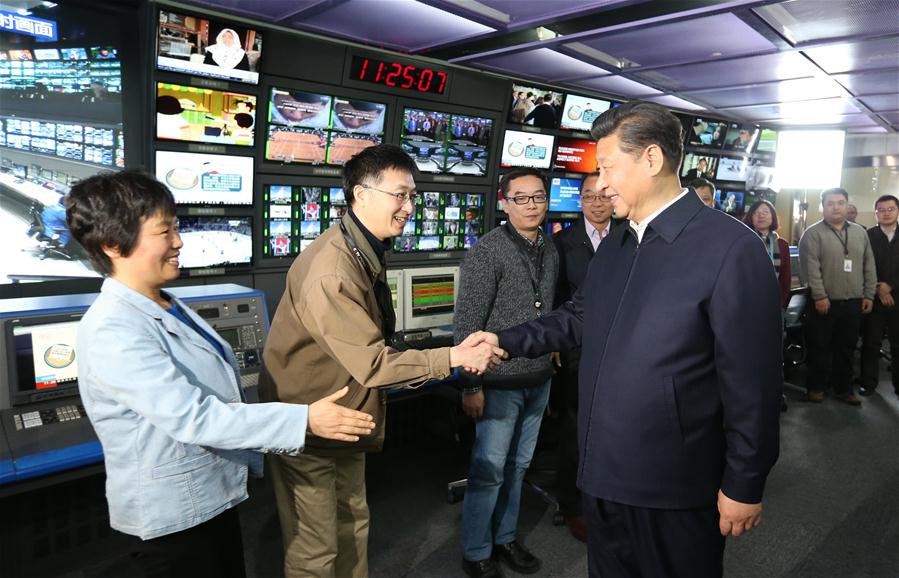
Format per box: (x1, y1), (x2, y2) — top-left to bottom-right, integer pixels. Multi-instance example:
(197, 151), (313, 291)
(799, 188), (877, 406)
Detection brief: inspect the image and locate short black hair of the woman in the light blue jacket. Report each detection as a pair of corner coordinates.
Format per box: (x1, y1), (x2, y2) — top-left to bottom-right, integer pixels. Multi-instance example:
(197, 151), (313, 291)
(63, 170), (175, 277)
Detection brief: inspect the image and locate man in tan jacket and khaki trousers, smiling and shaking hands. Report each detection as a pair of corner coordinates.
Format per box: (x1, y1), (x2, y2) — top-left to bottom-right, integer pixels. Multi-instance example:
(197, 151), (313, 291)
(259, 145), (504, 578)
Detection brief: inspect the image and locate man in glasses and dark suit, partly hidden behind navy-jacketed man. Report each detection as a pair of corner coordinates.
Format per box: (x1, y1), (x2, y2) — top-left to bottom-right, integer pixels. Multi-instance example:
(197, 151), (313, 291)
(552, 173), (613, 542)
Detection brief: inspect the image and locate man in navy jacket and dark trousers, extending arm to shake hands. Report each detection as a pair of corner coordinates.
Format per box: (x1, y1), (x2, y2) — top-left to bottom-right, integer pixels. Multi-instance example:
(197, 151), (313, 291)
(472, 101), (783, 578)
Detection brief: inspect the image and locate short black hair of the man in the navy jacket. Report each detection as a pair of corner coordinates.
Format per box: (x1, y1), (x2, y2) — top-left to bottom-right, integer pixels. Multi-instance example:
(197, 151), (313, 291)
(590, 100), (684, 173)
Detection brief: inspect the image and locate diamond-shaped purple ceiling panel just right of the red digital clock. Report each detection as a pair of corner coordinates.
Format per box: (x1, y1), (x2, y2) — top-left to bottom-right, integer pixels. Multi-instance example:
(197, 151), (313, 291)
(466, 48), (609, 82)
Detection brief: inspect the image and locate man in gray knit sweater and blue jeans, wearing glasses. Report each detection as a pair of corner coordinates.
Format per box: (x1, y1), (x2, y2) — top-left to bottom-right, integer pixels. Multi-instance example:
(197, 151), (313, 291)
(453, 169), (559, 578)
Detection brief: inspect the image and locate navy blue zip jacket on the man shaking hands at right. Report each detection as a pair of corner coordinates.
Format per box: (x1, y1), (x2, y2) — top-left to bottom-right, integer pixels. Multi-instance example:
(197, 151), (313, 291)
(499, 193), (783, 509)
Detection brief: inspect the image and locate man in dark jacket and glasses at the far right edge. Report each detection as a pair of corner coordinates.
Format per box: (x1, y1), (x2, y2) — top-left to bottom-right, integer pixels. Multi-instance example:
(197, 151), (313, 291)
(858, 195), (899, 397)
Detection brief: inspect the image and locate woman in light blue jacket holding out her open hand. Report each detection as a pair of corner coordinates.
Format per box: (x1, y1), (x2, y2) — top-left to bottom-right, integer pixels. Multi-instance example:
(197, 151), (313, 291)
(65, 171), (373, 577)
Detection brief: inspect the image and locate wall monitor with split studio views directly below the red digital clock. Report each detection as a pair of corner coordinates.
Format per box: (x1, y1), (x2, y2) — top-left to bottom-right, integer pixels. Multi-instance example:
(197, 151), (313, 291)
(400, 108), (493, 177)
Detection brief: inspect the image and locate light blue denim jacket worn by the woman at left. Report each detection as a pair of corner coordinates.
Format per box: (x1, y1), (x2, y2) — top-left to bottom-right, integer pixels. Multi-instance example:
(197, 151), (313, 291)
(77, 279), (308, 540)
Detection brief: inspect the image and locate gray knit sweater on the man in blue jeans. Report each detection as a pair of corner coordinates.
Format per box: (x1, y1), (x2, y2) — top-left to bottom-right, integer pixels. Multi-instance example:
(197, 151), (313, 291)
(453, 226), (559, 389)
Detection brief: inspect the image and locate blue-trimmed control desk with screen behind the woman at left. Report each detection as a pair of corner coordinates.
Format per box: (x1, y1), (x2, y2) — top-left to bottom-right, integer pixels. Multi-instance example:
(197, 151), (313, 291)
(0, 284), (268, 485)
